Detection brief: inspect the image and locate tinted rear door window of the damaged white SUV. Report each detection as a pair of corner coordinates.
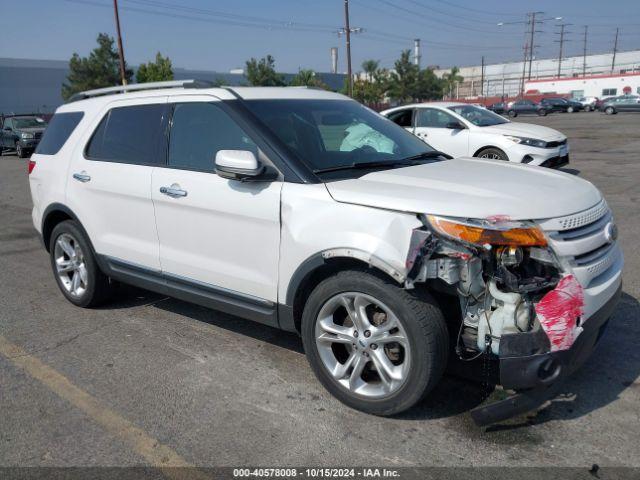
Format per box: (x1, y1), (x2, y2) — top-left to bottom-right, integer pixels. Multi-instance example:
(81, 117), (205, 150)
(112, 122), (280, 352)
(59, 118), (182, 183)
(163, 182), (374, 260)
(86, 104), (166, 165)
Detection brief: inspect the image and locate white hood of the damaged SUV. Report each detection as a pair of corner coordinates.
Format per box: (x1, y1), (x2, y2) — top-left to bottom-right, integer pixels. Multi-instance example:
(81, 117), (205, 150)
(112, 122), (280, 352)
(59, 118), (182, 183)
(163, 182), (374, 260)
(326, 158), (602, 220)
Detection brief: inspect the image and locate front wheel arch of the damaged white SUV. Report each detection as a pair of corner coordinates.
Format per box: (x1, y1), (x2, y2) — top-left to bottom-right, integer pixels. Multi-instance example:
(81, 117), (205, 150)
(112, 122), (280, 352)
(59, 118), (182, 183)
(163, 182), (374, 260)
(279, 248), (405, 333)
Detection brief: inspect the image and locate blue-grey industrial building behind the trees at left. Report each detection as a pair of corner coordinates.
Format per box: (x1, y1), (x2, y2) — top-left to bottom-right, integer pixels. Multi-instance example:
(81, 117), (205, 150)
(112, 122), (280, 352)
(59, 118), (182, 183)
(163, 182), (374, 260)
(0, 58), (345, 114)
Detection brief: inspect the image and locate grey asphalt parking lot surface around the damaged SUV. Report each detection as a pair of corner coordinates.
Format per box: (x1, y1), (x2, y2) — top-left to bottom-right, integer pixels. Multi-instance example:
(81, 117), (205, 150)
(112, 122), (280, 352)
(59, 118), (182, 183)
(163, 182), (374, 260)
(0, 109), (640, 468)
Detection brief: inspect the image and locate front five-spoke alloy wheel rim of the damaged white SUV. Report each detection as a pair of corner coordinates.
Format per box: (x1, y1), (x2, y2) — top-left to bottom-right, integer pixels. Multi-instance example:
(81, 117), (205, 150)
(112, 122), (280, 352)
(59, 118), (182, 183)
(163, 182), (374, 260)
(315, 292), (411, 399)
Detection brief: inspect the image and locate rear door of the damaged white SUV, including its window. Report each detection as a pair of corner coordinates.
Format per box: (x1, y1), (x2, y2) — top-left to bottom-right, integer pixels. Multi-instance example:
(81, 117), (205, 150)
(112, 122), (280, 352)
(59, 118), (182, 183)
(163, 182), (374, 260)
(67, 96), (167, 271)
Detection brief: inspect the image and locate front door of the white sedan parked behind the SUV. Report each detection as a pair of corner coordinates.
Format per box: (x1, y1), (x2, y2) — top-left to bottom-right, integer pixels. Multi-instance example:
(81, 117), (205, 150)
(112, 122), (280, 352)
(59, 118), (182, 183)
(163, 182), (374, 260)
(415, 108), (469, 158)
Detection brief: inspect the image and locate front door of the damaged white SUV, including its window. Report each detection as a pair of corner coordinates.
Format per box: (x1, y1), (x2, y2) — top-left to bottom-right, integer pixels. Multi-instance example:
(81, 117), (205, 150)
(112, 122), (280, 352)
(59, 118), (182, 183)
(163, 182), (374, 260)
(152, 95), (282, 305)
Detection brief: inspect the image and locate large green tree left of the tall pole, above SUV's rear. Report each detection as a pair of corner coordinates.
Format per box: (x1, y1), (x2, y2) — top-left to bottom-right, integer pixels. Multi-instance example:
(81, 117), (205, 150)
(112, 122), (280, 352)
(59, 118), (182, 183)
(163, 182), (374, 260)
(62, 33), (133, 100)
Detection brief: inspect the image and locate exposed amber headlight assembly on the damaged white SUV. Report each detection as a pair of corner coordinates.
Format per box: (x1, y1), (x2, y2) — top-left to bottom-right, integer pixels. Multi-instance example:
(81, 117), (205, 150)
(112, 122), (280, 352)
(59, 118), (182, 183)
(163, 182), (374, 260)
(427, 215), (547, 247)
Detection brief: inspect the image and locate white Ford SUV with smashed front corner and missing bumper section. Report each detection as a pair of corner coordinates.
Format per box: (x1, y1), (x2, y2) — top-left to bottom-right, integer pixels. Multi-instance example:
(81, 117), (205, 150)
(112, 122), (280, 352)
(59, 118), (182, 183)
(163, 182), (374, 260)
(29, 82), (623, 424)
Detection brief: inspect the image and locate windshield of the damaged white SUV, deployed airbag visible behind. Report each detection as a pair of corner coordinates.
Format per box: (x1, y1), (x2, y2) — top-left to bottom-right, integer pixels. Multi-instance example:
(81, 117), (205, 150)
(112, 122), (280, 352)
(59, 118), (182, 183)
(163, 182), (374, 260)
(245, 100), (434, 176)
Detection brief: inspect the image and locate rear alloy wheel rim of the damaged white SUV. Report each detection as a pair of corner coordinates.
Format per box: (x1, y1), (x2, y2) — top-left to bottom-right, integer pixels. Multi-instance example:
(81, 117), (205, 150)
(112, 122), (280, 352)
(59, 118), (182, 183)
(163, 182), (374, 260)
(54, 233), (89, 297)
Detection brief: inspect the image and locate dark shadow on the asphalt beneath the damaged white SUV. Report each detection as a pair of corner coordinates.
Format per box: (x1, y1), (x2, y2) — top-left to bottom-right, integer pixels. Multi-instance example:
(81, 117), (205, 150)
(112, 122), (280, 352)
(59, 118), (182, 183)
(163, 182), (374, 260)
(108, 286), (640, 426)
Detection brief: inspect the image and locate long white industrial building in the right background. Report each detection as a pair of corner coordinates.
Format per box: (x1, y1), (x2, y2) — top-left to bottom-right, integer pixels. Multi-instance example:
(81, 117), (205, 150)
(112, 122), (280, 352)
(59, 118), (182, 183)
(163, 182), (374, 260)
(435, 50), (640, 98)
